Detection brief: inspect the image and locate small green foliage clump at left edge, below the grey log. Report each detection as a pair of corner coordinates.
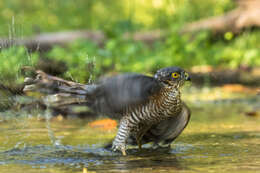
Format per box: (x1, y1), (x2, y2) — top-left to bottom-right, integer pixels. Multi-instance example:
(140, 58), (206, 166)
(0, 47), (38, 83)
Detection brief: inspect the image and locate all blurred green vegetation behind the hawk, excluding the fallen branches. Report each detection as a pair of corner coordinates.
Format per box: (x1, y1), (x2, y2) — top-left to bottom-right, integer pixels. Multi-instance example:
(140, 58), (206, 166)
(0, 0), (260, 83)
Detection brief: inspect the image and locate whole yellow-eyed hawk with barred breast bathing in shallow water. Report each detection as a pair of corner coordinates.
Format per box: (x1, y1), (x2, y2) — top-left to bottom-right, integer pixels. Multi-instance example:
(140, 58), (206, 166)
(23, 66), (191, 155)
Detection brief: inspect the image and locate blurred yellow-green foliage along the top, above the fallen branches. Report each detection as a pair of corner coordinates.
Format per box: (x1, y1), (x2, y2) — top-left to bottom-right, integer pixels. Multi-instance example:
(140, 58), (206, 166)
(0, 0), (234, 37)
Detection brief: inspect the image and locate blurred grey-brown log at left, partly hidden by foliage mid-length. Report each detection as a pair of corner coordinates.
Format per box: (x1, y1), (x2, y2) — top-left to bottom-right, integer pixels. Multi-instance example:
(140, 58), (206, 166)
(0, 30), (166, 51)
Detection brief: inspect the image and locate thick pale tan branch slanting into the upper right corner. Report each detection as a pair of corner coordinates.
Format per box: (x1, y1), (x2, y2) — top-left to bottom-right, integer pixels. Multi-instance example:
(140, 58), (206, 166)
(181, 0), (260, 33)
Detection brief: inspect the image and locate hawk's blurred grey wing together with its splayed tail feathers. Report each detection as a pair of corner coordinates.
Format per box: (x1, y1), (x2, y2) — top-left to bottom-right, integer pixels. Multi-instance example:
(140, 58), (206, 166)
(24, 71), (161, 118)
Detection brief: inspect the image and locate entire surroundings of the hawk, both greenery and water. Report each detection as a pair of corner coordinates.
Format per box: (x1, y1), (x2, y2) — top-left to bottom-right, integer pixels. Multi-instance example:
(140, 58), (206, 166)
(0, 0), (260, 172)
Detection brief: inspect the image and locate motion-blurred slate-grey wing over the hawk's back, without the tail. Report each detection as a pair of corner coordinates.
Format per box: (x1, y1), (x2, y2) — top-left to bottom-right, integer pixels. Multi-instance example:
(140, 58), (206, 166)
(90, 74), (161, 116)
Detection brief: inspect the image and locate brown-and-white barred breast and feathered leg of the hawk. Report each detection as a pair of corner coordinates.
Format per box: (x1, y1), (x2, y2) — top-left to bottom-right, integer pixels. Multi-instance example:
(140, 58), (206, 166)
(114, 87), (183, 150)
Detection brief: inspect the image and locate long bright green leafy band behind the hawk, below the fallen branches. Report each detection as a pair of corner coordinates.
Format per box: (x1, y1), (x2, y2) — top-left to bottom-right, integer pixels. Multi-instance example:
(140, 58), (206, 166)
(45, 31), (260, 82)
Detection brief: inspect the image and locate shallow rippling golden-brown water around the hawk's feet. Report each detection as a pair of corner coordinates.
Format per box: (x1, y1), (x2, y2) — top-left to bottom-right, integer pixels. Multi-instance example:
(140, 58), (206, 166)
(0, 90), (260, 173)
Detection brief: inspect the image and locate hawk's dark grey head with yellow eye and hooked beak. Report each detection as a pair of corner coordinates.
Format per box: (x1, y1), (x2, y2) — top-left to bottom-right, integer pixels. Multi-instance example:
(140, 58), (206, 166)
(154, 67), (191, 88)
